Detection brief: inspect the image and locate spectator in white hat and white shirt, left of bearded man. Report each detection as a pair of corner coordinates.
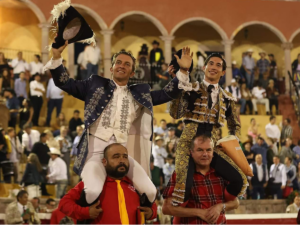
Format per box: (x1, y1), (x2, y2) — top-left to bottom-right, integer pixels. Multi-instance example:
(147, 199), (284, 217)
(47, 148), (68, 198)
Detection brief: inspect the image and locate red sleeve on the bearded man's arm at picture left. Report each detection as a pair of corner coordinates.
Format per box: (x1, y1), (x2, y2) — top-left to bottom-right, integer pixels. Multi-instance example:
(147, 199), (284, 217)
(58, 182), (90, 220)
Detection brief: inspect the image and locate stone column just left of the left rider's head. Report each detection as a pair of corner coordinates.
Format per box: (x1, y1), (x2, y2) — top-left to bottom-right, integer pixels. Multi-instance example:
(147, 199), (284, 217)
(101, 29), (114, 78)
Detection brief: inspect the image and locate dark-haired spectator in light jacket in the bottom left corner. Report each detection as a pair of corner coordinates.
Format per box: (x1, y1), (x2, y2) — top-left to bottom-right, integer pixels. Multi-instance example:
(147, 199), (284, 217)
(5, 190), (41, 224)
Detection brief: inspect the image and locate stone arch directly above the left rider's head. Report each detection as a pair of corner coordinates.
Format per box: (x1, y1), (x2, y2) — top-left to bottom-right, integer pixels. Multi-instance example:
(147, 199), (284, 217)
(109, 11), (168, 36)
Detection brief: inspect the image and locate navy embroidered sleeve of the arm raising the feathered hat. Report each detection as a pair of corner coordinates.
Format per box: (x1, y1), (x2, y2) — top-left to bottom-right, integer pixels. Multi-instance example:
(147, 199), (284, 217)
(50, 65), (92, 101)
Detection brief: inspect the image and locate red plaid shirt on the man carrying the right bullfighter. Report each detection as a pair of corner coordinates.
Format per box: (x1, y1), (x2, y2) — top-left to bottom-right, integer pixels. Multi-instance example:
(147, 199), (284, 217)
(163, 168), (227, 224)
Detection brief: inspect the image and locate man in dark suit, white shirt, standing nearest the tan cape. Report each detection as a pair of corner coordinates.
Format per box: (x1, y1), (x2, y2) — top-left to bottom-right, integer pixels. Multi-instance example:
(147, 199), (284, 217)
(249, 154), (269, 199)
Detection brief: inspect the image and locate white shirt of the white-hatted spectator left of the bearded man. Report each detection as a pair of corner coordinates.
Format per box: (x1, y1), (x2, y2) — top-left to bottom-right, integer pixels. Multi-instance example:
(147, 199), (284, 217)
(48, 157), (68, 181)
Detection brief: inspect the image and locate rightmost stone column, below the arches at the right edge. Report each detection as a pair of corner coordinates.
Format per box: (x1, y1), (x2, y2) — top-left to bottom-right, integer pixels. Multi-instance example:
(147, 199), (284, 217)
(281, 42), (293, 94)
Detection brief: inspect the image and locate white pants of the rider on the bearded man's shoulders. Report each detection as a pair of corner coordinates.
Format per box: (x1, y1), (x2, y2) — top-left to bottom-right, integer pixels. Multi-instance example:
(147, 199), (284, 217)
(81, 135), (157, 204)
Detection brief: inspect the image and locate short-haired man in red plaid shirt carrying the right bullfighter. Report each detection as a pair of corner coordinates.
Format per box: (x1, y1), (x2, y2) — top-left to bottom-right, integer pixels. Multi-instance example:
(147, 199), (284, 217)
(163, 134), (239, 224)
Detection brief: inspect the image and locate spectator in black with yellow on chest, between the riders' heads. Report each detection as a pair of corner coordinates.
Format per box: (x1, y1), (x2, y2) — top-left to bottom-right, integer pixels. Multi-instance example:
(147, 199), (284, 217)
(150, 40), (164, 82)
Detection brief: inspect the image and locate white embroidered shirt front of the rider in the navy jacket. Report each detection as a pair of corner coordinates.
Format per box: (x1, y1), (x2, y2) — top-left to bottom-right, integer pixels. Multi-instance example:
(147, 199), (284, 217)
(90, 83), (143, 143)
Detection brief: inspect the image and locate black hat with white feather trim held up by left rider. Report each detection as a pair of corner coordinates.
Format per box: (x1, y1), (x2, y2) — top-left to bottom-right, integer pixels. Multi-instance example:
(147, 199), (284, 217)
(51, 0), (95, 48)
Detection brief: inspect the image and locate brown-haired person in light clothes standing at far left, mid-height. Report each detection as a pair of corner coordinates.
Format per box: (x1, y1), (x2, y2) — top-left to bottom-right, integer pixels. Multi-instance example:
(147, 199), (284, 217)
(7, 127), (23, 183)
